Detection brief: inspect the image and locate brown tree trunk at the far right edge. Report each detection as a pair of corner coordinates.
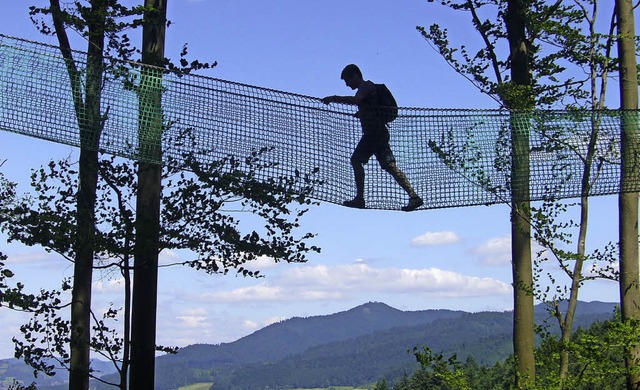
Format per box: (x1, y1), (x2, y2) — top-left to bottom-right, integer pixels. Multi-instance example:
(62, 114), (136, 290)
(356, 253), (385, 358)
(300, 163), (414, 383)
(616, 0), (640, 389)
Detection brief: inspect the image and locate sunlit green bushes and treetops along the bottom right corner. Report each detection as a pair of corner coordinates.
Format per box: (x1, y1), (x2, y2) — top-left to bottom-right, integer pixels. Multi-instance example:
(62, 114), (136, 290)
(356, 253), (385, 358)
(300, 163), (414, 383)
(393, 312), (640, 390)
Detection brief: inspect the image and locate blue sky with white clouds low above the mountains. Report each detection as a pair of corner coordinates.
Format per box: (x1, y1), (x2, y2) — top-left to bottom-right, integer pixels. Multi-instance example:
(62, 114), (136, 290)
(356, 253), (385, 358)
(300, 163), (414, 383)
(0, 0), (618, 358)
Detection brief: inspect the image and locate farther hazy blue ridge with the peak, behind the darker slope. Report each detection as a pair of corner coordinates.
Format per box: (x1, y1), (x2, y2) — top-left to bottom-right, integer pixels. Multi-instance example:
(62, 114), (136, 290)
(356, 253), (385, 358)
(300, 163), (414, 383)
(149, 302), (464, 388)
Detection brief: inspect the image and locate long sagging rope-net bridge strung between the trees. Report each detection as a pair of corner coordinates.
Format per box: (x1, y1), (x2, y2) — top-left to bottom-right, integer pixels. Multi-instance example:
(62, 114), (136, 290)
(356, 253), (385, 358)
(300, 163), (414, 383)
(0, 35), (640, 210)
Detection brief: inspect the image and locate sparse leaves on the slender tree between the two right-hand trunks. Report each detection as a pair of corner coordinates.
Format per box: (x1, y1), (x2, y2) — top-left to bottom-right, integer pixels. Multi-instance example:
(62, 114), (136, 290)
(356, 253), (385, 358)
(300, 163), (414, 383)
(531, 1), (620, 387)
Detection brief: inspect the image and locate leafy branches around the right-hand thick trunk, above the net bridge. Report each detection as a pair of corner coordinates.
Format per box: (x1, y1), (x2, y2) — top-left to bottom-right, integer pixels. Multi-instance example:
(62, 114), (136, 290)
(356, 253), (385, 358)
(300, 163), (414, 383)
(417, 0), (618, 109)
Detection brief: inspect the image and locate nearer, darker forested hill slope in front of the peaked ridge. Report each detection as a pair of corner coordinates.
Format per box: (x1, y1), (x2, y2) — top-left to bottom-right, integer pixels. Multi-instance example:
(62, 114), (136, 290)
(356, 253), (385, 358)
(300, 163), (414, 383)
(212, 302), (615, 390)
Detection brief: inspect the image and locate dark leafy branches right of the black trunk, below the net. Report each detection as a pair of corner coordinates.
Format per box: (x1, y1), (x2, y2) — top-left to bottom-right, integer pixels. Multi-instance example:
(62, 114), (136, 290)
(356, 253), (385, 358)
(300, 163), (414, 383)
(161, 129), (321, 276)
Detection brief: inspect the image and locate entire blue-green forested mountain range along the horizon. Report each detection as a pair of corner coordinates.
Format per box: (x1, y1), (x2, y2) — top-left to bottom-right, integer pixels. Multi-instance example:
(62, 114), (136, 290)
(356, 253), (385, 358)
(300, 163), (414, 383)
(0, 302), (615, 390)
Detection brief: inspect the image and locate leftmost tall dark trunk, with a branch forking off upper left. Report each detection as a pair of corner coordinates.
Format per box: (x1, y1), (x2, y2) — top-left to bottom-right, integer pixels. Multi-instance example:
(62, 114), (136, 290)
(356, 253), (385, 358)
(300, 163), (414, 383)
(67, 0), (106, 390)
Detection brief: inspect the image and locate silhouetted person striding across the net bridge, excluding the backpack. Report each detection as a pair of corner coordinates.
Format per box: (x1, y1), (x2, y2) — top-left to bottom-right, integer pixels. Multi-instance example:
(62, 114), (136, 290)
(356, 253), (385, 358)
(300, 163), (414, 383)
(321, 64), (423, 211)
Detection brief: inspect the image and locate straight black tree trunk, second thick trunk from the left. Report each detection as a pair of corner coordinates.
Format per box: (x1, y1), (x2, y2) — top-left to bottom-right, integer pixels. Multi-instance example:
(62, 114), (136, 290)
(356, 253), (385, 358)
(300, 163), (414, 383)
(130, 0), (167, 389)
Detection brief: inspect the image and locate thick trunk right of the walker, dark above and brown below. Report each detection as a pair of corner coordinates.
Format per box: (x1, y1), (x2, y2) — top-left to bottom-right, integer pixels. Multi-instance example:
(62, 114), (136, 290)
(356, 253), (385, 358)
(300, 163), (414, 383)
(505, 0), (535, 388)
